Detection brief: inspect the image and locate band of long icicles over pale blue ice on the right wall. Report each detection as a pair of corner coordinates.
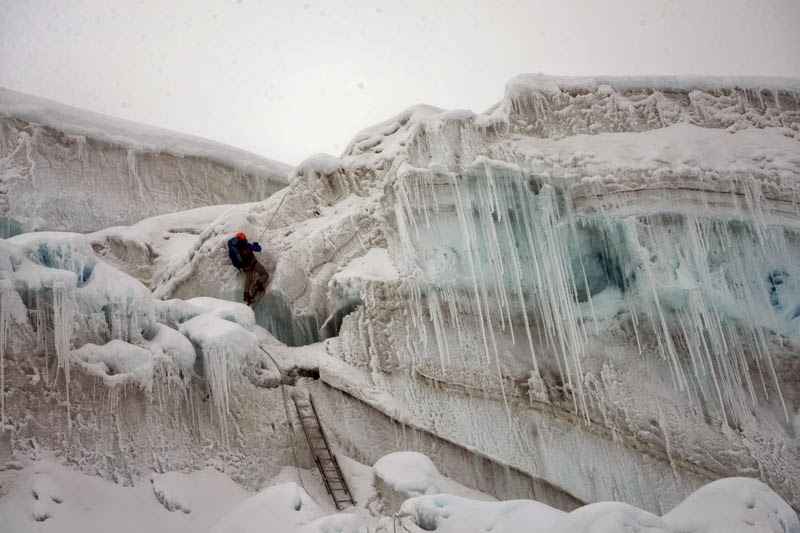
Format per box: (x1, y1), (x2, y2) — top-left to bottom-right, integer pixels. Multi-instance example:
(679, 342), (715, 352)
(398, 160), (800, 425)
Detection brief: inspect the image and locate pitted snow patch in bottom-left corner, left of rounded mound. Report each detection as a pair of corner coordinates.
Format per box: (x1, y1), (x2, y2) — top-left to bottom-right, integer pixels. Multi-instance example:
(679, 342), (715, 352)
(0, 460), (248, 533)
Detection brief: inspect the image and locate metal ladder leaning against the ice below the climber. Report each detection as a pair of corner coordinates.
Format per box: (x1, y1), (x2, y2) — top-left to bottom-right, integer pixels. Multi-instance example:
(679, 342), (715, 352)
(292, 389), (356, 510)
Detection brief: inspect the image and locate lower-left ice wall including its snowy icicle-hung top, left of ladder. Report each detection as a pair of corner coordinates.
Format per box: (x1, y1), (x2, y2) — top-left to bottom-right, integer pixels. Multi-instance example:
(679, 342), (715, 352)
(0, 232), (310, 488)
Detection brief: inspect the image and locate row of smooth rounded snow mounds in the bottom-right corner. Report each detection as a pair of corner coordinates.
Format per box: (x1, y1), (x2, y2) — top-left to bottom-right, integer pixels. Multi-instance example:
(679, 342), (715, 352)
(397, 478), (800, 533)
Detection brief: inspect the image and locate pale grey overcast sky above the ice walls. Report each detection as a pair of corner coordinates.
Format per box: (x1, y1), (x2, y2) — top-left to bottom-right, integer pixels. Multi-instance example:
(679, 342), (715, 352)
(0, 0), (800, 164)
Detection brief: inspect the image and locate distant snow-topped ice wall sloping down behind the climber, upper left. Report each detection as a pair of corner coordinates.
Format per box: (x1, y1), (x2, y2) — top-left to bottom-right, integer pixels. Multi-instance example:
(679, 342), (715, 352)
(0, 88), (291, 237)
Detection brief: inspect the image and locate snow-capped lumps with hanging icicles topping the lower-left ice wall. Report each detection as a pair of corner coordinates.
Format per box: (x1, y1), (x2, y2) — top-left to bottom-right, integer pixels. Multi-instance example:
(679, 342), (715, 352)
(0, 232), (276, 474)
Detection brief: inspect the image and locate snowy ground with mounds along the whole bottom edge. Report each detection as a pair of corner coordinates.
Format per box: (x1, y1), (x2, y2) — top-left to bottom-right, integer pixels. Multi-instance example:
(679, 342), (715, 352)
(0, 455), (800, 533)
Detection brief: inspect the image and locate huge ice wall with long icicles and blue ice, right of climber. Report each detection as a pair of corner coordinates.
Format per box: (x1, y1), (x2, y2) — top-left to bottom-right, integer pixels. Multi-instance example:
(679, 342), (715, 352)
(222, 76), (800, 510)
